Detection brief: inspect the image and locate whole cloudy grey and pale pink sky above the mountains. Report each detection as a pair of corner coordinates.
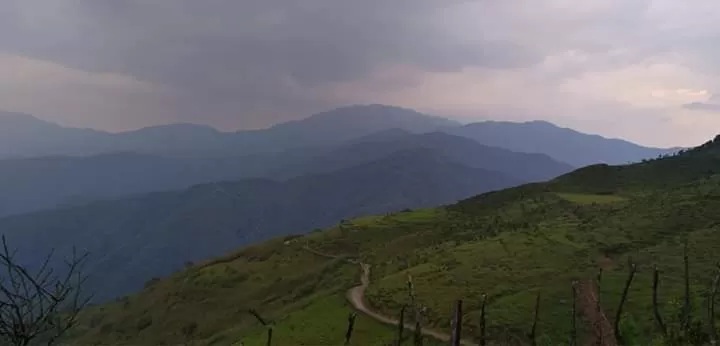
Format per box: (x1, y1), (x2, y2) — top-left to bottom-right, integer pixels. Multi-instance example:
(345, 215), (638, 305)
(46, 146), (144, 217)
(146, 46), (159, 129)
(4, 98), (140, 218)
(0, 0), (720, 146)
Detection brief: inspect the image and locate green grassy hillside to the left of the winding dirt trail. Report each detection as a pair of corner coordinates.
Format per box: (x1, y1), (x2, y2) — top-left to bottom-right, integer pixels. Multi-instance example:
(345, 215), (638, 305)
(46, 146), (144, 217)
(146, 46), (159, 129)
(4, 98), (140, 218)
(71, 237), (448, 346)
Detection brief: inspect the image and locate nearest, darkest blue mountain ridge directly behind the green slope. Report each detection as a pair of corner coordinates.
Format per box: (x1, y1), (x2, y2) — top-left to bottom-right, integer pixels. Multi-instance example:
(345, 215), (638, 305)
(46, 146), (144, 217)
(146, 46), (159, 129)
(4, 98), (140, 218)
(0, 148), (522, 299)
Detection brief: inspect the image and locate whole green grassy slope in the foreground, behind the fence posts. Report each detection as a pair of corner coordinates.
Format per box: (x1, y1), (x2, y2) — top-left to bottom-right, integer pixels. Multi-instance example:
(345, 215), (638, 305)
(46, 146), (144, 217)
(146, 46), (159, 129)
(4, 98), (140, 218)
(69, 137), (720, 345)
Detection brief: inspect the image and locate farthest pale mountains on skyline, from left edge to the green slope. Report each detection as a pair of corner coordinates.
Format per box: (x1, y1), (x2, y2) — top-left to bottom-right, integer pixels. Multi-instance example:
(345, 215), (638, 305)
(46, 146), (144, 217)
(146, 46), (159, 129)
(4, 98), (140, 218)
(0, 105), (676, 167)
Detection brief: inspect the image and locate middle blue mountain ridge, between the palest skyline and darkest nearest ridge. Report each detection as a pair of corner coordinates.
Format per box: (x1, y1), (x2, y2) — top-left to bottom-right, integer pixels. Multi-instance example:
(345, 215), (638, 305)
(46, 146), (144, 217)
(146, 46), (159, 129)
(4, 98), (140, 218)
(0, 131), (572, 216)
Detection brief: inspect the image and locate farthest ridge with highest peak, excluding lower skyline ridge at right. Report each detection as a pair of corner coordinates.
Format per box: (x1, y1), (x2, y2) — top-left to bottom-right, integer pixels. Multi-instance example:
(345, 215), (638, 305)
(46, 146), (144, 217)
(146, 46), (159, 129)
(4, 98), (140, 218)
(0, 105), (458, 158)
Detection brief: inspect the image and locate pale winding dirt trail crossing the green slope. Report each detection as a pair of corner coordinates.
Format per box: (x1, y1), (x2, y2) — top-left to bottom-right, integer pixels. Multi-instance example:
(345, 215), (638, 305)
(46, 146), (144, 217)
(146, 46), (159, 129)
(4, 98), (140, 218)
(303, 246), (477, 346)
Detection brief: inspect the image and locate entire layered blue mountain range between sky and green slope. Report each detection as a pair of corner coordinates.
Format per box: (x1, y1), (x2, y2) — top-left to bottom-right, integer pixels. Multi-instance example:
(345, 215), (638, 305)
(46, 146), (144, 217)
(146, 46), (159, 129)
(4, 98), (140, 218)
(0, 105), (680, 299)
